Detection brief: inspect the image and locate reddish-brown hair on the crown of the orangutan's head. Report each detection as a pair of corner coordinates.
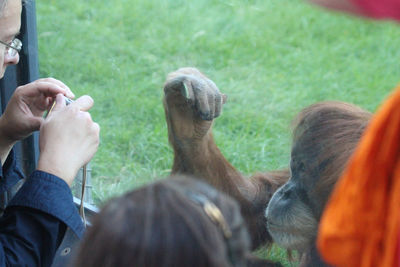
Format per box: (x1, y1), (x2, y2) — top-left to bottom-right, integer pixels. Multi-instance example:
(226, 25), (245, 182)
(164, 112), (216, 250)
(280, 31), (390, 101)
(292, 101), (372, 215)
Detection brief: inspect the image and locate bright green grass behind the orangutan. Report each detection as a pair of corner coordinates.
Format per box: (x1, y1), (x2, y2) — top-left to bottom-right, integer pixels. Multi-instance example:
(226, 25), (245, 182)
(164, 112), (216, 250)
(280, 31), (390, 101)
(37, 0), (400, 266)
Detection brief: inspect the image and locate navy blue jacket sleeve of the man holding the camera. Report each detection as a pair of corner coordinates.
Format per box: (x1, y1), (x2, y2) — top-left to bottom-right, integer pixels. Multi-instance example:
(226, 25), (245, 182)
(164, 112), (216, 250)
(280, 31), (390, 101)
(0, 150), (84, 266)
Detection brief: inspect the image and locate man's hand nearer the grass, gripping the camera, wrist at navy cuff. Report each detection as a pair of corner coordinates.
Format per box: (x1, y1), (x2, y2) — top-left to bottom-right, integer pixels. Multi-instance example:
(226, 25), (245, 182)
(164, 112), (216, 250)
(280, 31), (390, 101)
(38, 94), (100, 185)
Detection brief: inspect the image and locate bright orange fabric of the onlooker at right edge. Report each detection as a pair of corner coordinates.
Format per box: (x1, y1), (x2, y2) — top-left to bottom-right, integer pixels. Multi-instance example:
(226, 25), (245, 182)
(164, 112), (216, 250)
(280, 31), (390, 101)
(317, 86), (400, 267)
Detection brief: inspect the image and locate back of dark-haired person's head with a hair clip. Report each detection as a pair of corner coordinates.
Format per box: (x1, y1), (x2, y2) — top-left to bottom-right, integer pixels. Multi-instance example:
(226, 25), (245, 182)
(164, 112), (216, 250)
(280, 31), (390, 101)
(74, 176), (250, 267)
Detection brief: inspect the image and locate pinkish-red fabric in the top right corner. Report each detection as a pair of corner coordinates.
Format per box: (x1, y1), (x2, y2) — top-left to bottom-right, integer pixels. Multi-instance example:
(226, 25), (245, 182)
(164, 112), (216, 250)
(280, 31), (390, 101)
(352, 0), (400, 22)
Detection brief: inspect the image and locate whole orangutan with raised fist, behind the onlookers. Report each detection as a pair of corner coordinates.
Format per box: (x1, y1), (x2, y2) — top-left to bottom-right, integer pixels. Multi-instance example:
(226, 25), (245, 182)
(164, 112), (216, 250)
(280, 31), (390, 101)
(163, 68), (370, 266)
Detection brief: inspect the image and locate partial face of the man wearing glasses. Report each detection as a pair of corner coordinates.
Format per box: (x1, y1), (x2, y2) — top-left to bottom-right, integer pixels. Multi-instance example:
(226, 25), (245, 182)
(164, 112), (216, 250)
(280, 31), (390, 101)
(0, 0), (22, 79)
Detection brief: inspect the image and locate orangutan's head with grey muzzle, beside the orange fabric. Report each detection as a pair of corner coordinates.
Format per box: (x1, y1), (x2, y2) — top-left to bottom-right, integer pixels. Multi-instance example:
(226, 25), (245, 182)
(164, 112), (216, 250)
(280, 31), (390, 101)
(267, 101), (371, 266)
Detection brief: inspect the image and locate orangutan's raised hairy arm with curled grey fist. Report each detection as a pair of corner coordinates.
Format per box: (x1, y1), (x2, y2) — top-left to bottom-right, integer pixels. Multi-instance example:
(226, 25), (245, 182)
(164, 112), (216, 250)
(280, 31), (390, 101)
(163, 68), (289, 251)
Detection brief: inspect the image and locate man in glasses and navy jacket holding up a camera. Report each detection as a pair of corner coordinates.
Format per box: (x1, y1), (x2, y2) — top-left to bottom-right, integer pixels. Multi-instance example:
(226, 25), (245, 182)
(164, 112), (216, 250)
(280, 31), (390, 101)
(0, 0), (100, 266)
